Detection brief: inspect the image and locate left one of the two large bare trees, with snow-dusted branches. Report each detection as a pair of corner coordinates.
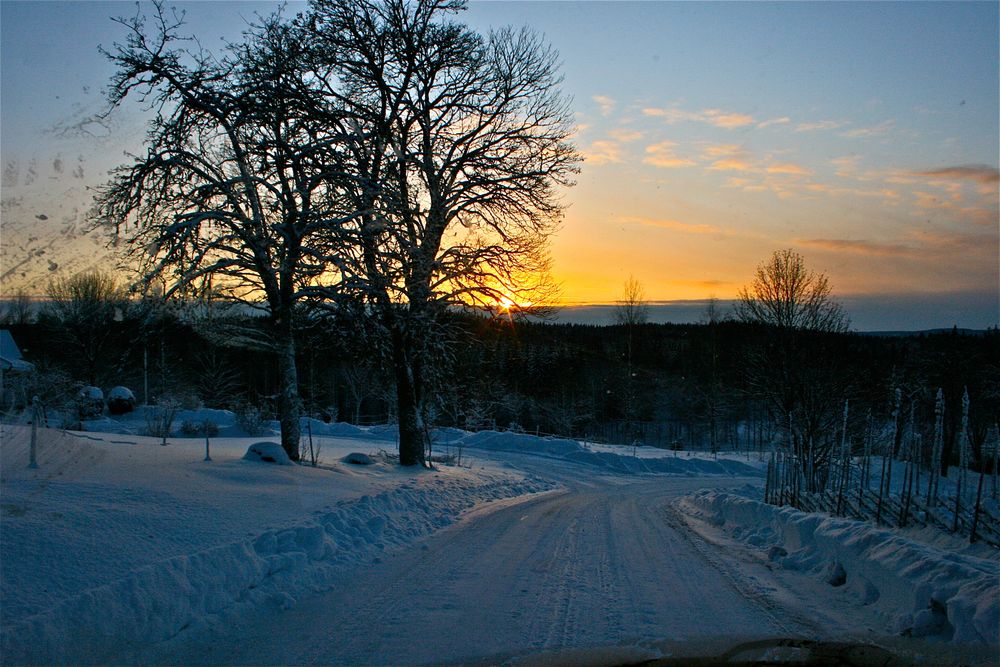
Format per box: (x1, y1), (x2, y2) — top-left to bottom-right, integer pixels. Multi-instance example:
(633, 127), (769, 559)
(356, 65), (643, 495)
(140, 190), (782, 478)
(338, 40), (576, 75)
(97, 3), (350, 460)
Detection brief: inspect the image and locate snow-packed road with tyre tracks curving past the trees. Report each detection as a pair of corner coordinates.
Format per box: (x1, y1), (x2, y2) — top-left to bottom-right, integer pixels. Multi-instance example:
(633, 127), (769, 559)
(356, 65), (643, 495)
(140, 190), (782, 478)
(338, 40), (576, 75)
(156, 460), (814, 665)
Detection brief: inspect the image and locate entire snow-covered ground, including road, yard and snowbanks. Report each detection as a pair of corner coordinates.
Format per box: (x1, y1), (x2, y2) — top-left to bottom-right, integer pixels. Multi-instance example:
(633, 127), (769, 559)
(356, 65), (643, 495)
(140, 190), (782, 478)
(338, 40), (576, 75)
(0, 413), (1000, 664)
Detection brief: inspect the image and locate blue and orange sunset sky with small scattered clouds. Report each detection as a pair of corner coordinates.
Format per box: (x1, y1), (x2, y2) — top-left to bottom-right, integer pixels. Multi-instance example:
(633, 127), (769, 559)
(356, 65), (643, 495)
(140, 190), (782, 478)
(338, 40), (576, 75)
(0, 0), (1000, 330)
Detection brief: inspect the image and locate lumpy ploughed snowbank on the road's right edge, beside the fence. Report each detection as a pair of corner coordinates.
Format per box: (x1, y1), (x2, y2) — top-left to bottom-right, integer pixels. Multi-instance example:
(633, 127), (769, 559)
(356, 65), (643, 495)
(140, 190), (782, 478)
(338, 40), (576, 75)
(680, 491), (1000, 645)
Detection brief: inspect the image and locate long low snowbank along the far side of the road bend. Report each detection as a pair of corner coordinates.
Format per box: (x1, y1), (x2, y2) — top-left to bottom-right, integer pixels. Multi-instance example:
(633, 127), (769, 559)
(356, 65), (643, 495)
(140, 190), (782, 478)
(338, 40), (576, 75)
(458, 431), (761, 476)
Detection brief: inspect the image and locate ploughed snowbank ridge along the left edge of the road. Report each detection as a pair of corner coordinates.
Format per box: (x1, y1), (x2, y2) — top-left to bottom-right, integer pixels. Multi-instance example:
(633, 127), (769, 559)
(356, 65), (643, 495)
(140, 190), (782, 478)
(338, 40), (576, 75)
(2, 473), (552, 664)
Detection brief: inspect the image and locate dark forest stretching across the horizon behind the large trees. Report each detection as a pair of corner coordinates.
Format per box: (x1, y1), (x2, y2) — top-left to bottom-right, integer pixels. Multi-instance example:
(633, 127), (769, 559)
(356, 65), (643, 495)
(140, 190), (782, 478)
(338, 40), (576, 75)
(3, 288), (1000, 480)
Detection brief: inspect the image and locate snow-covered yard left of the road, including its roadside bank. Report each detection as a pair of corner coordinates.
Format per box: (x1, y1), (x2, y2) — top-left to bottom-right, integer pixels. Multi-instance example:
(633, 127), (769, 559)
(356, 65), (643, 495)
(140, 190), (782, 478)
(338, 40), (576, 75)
(0, 426), (553, 664)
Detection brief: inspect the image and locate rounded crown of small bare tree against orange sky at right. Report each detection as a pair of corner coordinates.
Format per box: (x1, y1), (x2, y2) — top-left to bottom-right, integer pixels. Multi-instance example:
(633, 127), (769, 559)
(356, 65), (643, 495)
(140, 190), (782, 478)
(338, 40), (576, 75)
(736, 249), (850, 332)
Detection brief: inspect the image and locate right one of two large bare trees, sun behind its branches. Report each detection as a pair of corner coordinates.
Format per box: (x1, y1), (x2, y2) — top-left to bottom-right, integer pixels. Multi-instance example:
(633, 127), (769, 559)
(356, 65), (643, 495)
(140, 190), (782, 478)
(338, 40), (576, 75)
(302, 0), (579, 465)
